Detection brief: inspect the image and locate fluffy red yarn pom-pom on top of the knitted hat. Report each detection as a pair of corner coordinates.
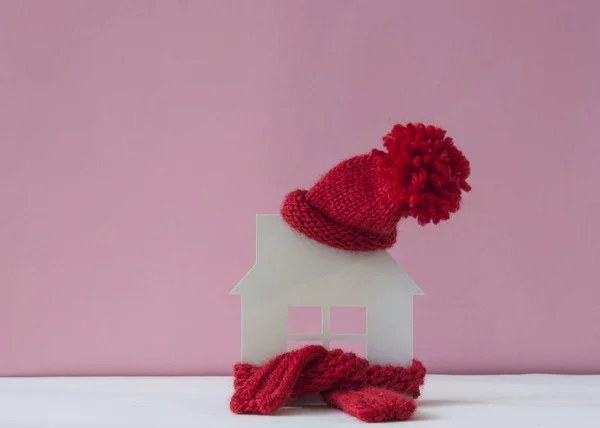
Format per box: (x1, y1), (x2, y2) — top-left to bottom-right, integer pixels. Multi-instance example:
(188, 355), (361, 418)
(373, 123), (471, 225)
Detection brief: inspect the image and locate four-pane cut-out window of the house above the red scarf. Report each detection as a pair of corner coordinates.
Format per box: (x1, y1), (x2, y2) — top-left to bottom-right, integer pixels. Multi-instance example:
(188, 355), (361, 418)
(287, 306), (367, 358)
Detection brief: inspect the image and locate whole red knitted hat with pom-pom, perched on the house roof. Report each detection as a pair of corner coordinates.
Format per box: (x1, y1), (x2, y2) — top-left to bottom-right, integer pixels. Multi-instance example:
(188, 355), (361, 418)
(281, 123), (471, 251)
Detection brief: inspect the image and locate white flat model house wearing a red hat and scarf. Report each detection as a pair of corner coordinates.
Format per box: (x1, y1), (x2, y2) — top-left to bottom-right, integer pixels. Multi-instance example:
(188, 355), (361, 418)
(231, 215), (423, 365)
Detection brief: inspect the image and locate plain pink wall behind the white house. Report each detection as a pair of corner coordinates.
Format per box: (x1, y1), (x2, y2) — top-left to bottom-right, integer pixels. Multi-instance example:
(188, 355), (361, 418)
(0, 0), (600, 375)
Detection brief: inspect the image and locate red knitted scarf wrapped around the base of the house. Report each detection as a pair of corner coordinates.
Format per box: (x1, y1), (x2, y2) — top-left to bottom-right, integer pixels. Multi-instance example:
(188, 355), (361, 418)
(230, 345), (425, 422)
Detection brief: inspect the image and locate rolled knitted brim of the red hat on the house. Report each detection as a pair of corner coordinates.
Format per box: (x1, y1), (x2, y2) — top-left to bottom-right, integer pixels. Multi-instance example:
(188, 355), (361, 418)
(281, 190), (397, 251)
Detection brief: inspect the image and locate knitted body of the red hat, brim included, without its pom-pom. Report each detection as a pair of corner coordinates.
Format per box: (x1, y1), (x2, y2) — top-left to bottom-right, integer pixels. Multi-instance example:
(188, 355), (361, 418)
(281, 154), (405, 251)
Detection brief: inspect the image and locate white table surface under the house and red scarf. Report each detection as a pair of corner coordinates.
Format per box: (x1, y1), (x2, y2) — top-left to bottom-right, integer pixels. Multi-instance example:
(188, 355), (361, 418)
(0, 375), (600, 428)
